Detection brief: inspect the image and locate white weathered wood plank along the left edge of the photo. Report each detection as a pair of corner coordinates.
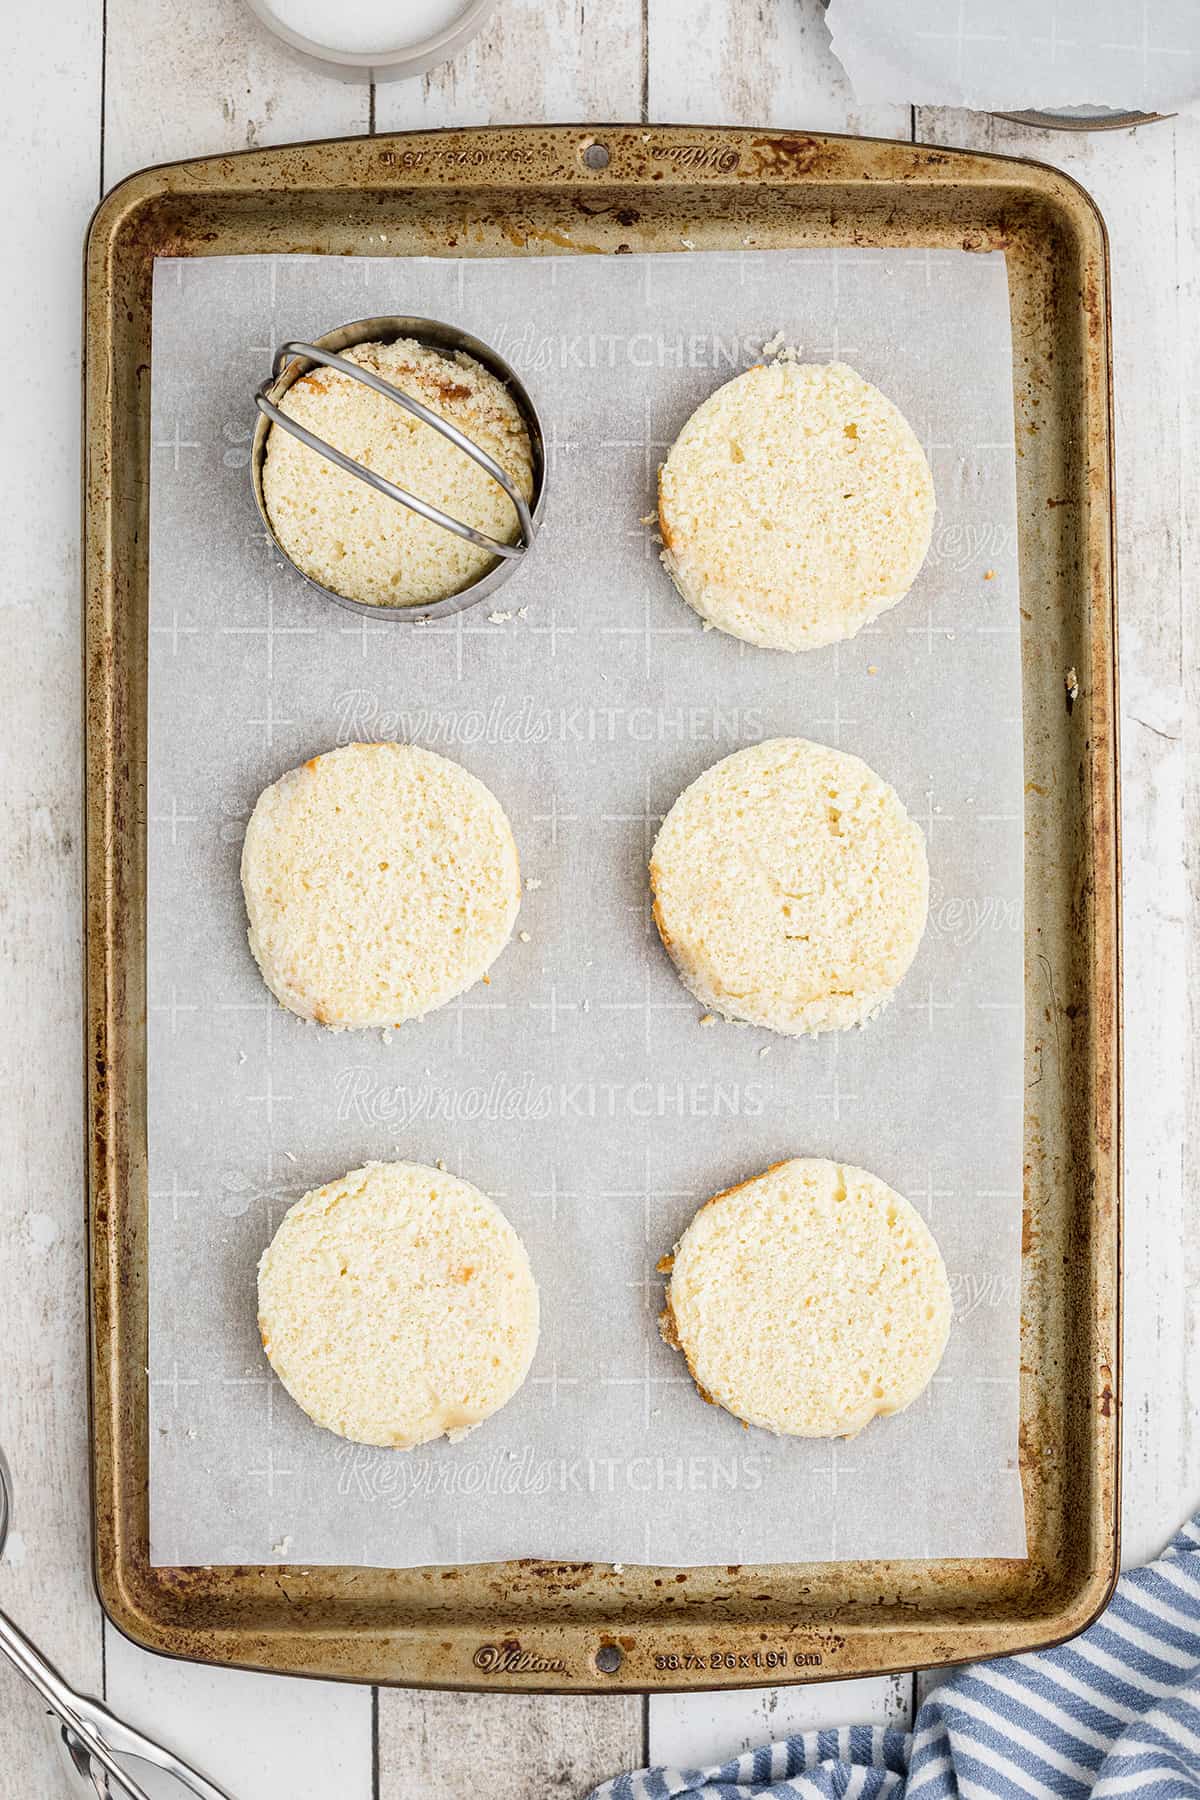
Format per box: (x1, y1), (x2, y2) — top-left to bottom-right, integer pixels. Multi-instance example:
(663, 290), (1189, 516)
(0, 0), (101, 1800)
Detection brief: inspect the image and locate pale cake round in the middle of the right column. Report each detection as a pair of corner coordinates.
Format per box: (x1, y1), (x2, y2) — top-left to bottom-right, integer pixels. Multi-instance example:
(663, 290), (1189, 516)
(649, 738), (928, 1037)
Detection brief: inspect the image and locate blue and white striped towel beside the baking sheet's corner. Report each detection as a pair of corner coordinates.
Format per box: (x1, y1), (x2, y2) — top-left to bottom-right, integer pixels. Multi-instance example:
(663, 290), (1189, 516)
(592, 1514), (1200, 1800)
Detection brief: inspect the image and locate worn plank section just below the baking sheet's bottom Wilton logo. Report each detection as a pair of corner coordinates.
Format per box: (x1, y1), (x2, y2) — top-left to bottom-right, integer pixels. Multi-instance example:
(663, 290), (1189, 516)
(378, 1688), (644, 1800)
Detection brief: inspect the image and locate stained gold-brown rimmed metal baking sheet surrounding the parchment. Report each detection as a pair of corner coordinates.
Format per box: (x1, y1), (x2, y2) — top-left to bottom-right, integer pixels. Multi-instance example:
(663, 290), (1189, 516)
(85, 128), (1119, 1688)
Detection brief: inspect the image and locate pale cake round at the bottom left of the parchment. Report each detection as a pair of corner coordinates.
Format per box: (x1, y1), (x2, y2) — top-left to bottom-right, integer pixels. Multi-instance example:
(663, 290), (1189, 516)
(259, 1163), (538, 1449)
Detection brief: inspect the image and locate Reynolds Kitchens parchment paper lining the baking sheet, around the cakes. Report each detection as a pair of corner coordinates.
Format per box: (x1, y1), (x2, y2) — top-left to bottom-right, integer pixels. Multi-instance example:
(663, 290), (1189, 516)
(148, 247), (1024, 1566)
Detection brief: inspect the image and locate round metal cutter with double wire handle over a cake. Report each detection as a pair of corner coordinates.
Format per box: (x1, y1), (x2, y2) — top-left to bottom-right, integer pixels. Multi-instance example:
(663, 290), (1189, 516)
(250, 317), (545, 621)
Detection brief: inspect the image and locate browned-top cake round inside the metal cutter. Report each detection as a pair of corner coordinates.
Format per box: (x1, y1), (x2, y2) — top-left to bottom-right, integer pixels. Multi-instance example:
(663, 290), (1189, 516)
(263, 338), (533, 607)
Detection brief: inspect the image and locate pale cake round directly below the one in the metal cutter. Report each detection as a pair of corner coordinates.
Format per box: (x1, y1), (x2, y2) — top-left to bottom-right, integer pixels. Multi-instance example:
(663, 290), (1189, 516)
(241, 743), (520, 1030)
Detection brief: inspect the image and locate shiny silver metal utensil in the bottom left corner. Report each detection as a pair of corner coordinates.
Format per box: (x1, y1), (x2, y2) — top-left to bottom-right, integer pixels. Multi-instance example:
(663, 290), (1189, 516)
(0, 1451), (230, 1800)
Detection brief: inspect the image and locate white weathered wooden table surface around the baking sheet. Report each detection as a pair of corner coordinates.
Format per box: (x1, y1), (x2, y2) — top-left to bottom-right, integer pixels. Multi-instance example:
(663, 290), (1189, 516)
(0, 0), (1200, 1800)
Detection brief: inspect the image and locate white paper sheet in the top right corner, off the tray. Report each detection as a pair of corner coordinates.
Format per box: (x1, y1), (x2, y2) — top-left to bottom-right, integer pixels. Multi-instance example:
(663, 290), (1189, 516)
(829, 0), (1200, 112)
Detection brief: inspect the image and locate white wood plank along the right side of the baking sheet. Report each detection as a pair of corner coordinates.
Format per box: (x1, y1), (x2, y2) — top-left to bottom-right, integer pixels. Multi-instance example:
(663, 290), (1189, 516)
(918, 112), (1200, 1564)
